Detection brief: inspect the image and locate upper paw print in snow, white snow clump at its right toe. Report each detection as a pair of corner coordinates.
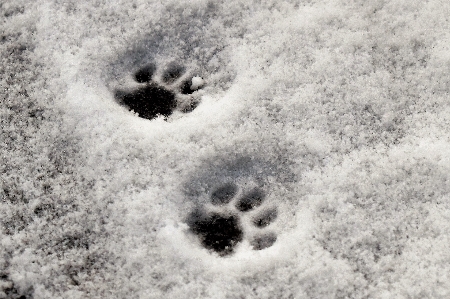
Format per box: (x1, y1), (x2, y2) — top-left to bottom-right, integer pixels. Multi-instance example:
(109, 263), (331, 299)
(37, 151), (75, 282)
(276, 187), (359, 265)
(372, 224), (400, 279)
(115, 62), (205, 119)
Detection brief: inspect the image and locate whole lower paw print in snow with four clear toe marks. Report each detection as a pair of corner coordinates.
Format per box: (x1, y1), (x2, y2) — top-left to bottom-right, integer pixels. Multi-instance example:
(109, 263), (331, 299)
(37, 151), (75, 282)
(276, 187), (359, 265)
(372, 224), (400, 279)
(187, 183), (277, 256)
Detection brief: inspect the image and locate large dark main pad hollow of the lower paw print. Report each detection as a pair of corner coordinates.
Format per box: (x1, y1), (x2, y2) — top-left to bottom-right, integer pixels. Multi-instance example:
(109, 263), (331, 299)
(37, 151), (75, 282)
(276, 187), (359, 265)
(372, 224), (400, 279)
(188, 210), (242, 256)
